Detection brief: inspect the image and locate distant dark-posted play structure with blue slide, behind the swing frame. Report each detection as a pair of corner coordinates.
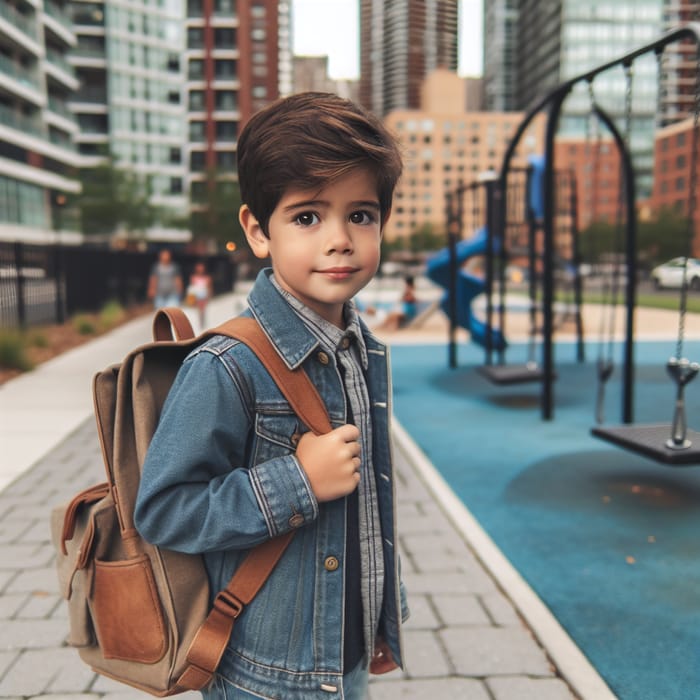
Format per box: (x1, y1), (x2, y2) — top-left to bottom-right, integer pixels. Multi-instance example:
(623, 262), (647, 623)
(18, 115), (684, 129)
(427, 156), (584, 384)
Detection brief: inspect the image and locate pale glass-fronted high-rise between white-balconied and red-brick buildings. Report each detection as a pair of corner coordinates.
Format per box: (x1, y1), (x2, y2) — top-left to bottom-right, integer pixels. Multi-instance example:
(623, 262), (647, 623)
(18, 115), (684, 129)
(69, 0), (187, 213)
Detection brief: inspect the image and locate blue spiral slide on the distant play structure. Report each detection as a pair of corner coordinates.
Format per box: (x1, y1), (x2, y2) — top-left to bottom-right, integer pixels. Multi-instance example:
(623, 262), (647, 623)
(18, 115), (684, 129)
(427, 227), (506, 350)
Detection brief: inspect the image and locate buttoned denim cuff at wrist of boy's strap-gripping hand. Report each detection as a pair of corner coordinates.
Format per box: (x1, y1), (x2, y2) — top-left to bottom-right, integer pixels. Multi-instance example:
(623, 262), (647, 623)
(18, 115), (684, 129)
(250, 455), (318, 537)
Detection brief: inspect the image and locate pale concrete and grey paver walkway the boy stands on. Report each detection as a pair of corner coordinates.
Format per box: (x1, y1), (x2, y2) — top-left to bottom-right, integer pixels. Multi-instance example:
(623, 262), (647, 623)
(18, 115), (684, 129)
(0, 288), (614, 700)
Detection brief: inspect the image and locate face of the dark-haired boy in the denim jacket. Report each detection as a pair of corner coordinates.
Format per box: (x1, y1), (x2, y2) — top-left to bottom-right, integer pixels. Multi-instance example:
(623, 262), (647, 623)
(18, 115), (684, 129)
(240, 169), (381, 327)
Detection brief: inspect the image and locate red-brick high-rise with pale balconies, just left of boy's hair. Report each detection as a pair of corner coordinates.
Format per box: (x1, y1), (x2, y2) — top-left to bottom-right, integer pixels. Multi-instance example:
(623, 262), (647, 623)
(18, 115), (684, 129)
(184, 0), (292, 208)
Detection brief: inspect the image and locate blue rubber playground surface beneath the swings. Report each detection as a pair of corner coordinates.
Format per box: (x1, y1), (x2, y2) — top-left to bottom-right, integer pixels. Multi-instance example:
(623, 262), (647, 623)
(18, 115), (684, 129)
(392, 342), (700, 700)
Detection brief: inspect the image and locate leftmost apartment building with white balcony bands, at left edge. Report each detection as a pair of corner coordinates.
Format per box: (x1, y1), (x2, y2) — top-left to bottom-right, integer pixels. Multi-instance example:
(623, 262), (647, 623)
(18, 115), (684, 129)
(0, 0), (80, 241)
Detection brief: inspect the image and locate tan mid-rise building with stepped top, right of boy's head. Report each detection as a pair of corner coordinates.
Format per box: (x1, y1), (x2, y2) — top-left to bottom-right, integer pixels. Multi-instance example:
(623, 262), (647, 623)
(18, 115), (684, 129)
(385, 70), (544, 240)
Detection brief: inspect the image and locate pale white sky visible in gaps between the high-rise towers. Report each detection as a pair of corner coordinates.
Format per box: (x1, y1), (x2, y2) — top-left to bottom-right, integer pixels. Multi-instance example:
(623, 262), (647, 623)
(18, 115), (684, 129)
(292, 0), (482, 80)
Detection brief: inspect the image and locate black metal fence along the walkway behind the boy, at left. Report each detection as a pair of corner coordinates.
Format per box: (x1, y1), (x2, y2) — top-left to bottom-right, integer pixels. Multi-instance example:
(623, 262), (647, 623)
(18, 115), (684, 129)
(0, 242), (237, 328)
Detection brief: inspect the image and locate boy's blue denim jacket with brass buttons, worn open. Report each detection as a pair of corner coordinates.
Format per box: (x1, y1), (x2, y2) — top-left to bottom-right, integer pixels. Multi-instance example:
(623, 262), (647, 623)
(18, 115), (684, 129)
(135, 270), (407, 700)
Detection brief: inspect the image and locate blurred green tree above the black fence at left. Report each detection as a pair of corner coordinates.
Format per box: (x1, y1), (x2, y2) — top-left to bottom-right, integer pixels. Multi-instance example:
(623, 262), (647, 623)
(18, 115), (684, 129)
(76, 156), (158, 235)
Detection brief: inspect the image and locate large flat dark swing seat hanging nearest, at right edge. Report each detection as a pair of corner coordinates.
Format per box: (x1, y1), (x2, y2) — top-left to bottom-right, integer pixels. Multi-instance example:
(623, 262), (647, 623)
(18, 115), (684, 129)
(591, 423), (700, 467)
